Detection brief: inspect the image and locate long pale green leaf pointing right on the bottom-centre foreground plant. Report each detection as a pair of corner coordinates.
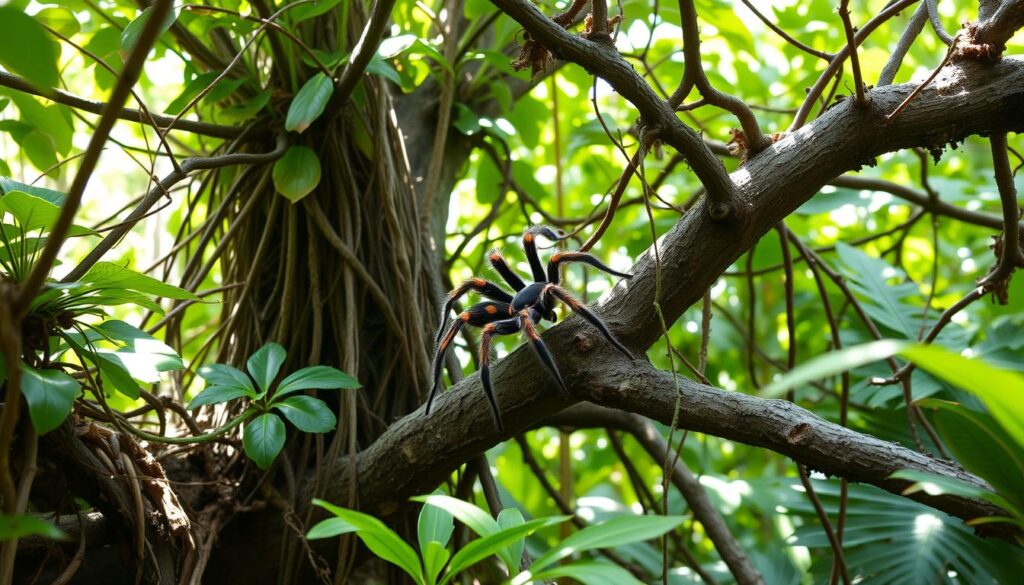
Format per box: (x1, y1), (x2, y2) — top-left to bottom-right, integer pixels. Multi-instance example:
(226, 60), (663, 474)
(529, 516), (686, 573)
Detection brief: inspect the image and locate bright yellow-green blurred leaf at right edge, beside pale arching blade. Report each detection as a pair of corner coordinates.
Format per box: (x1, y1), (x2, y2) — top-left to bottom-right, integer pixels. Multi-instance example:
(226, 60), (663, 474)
(900, 345), (1024, 450)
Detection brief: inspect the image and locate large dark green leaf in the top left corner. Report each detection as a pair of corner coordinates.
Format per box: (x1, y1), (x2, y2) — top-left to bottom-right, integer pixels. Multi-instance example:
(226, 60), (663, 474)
(0, 6), (59, 90)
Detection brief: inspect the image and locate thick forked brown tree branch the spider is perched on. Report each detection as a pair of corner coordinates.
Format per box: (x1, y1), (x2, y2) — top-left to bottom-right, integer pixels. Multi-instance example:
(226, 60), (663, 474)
(315, 58), (1024, 536)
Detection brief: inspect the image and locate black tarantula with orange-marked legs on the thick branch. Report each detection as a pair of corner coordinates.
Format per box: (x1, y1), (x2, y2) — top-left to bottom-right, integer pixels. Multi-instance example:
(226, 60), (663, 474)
(426, 225), (633, 430)
